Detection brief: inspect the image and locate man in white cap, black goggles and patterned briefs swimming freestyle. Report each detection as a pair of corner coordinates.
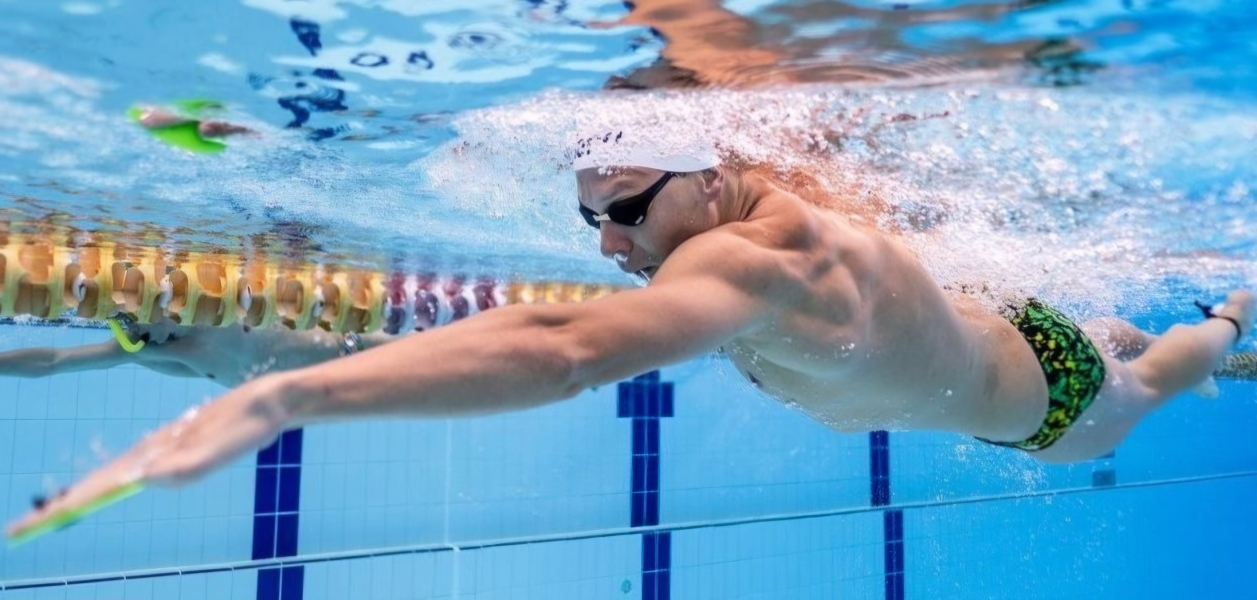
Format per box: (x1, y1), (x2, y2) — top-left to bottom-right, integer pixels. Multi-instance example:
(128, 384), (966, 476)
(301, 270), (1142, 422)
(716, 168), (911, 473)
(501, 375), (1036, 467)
(9, 131), (1253, 535)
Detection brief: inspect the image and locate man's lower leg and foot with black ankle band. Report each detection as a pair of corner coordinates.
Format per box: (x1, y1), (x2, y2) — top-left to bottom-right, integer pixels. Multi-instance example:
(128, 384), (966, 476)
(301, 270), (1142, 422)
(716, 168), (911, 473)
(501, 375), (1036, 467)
(1129, 292), (1253, 405)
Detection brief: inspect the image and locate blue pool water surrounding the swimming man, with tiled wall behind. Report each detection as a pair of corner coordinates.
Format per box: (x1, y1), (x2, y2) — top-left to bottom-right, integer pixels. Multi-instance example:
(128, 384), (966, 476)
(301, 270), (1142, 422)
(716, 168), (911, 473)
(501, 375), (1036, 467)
(0, 0), (1257, 600)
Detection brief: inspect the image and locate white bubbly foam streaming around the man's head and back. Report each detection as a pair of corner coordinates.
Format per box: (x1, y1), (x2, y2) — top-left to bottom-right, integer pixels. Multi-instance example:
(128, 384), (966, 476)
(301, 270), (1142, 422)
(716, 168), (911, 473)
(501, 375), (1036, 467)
(415, 88), (1257, 314)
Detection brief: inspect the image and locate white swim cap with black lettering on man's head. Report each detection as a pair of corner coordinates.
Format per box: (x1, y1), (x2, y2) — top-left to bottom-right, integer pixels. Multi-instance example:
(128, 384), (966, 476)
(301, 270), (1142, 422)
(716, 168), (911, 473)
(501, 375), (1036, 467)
(572, 130), (720, 172)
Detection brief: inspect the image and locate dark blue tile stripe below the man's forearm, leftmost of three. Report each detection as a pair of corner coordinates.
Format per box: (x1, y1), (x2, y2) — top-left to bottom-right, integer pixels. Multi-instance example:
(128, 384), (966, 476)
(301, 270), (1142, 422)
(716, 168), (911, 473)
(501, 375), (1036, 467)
(253, 429), (305, 600)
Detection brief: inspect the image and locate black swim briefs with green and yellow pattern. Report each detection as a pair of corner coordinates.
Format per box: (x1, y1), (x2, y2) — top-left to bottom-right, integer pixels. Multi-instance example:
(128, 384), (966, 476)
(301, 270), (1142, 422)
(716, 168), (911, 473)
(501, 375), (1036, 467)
(978, 299), (1105, 452)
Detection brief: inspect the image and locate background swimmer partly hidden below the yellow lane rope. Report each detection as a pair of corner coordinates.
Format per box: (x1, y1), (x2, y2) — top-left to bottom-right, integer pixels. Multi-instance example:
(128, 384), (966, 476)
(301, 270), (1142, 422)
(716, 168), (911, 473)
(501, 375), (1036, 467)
(0, 318), (397, 387)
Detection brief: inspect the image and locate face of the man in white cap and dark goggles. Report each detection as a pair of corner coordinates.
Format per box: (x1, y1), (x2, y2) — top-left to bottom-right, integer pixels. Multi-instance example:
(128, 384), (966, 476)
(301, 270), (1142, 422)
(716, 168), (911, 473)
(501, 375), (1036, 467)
(576, 167), (722, 279)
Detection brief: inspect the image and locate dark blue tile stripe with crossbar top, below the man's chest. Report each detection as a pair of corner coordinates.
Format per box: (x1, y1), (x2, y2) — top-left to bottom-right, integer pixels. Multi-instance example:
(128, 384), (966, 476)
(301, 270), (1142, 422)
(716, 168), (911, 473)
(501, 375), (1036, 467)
(616, 371), (672, 600)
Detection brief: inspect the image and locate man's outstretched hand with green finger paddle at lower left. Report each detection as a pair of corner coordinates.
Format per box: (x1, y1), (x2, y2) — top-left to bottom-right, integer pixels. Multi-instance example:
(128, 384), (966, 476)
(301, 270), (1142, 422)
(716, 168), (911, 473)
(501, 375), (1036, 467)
(6, 376), (288, 541)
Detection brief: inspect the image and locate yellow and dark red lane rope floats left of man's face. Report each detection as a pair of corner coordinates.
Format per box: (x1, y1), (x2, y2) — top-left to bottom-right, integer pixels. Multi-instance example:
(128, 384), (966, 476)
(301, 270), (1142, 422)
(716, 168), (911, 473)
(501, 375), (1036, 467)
(0, 235), (618, 333)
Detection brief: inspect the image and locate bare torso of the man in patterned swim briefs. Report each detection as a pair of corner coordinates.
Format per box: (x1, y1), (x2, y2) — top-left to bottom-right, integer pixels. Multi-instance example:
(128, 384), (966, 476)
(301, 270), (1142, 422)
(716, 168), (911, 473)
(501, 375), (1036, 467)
(724, 187), (1047, 439)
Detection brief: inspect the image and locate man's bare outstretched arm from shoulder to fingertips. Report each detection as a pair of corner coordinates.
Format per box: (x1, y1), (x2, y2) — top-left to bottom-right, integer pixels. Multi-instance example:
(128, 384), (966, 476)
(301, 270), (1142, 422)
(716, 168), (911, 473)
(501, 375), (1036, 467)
(9, 228), (789, 535)
